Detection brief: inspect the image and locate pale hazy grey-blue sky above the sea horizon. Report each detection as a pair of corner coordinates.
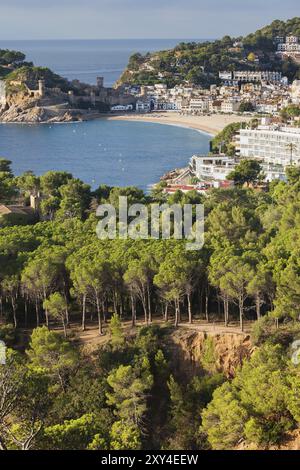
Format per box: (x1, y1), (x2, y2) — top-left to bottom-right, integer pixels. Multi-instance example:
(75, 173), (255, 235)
(0, 0), (300, 39)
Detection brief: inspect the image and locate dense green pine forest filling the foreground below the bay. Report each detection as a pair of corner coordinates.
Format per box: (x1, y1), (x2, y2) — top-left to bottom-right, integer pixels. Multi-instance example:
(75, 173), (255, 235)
(0, 155), (300, 449)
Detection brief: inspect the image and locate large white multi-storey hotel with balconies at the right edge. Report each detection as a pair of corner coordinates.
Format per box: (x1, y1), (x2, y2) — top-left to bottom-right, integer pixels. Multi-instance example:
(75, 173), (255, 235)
(237, 126), (300, 168)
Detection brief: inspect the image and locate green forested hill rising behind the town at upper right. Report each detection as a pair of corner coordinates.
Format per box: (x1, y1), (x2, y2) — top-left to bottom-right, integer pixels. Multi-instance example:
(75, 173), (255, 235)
(120, 17), (300, 86)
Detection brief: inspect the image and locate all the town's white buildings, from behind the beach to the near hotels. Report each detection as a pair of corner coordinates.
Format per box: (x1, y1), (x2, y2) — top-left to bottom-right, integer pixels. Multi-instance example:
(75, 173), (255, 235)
(111, 36), (300, 194)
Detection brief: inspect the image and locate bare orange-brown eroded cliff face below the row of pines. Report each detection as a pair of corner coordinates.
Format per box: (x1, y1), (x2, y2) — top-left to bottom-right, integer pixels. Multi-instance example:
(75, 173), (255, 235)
(169, 329), (253, 379)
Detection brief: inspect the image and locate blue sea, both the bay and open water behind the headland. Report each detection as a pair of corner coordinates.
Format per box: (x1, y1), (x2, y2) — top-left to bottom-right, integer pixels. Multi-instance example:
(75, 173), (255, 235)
(0, 39), (210, 191)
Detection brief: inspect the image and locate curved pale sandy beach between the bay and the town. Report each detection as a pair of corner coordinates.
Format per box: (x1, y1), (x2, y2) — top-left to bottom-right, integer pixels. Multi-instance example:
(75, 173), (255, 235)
(107, 112), (252, 135)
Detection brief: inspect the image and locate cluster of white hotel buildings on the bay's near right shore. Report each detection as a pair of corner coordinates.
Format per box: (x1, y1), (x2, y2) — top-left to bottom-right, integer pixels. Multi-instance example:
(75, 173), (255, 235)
(155, 117), (300, 194)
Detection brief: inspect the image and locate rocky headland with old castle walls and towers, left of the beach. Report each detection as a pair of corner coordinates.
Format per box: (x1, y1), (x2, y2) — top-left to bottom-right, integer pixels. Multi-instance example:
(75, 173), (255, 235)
(0, 49), (135, 123)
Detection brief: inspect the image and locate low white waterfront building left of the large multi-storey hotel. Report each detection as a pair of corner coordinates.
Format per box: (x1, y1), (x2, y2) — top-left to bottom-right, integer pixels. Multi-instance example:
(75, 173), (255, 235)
(190, 155), (236, 181)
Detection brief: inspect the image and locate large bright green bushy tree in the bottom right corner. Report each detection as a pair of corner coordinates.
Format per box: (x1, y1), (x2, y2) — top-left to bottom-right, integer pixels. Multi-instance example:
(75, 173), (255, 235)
(200, 338), (300, 450)
